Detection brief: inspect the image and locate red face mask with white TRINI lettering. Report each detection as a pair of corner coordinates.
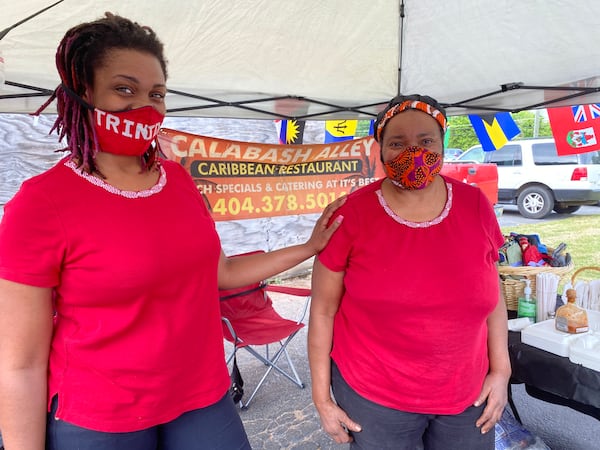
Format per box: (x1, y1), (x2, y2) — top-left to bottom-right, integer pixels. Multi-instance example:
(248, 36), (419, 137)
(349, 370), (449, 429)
(94, 105), (165, 156)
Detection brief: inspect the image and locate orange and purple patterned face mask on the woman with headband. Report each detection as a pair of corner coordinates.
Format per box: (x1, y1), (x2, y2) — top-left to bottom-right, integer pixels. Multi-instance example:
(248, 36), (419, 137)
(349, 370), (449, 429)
(383, 147), (442, 191)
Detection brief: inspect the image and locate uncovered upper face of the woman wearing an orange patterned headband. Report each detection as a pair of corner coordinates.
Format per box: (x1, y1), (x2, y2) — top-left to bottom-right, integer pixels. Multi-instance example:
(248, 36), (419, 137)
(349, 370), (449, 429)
(381, 109), (444, 162)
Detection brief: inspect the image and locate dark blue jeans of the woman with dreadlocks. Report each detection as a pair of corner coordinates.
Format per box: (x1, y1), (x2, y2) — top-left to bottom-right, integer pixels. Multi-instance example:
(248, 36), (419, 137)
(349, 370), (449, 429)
(46, 393), (251, 450)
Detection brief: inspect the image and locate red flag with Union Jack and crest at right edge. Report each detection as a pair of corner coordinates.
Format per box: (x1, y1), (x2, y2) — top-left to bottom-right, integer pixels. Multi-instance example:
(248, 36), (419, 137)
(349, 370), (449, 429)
(547, 103), (600, 155)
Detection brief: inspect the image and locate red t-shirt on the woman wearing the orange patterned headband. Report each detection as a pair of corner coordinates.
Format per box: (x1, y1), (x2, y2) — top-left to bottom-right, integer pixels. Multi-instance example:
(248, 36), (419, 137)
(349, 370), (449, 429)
(319, 178), (503, 414)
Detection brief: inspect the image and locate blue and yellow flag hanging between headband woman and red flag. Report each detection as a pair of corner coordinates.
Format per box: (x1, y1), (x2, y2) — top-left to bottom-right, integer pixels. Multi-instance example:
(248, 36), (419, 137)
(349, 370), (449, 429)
(469, 112), (521, 152)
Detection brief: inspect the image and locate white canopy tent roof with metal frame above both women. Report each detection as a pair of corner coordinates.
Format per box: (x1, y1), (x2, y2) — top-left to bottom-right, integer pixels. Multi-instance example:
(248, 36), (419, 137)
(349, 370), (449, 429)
(0, 0), (600, 119)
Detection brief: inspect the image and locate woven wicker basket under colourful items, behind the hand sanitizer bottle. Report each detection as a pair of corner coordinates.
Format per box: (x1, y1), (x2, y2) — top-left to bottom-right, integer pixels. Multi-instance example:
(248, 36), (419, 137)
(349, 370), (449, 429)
(498, 261), (575, 311)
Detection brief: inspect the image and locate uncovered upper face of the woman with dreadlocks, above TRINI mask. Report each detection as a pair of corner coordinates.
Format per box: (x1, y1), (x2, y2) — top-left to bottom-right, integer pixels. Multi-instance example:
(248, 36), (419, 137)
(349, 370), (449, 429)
(84, 49), (167, 114)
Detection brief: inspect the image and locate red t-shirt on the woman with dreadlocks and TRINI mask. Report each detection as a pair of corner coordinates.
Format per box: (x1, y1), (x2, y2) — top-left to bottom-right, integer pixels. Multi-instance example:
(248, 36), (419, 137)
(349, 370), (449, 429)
(0, 160), (229, 432)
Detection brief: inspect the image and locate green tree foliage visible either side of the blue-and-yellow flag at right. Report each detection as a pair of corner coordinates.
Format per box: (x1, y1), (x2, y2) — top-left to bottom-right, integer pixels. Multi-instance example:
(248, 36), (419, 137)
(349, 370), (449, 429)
(446, 111), (552, 150)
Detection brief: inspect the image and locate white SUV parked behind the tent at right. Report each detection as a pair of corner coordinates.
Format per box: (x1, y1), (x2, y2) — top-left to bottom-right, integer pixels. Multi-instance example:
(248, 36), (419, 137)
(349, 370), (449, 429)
(455, 138), (600, 219)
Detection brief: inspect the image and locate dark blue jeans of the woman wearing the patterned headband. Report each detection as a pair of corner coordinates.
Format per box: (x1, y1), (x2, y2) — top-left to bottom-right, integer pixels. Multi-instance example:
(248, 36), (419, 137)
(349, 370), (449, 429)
(331, 361), (495, 450)
